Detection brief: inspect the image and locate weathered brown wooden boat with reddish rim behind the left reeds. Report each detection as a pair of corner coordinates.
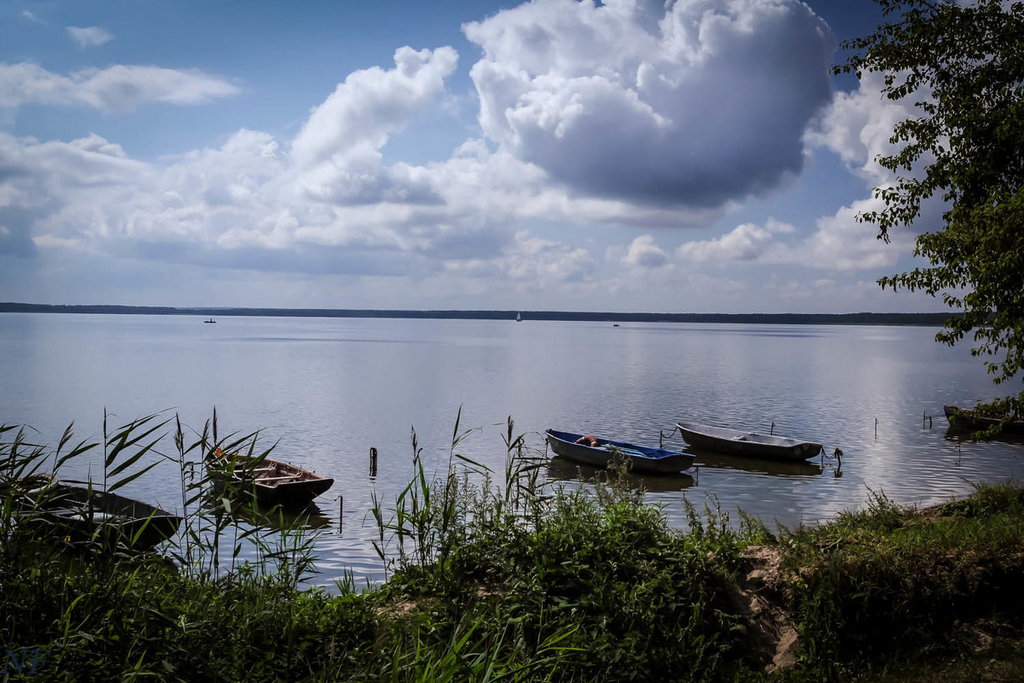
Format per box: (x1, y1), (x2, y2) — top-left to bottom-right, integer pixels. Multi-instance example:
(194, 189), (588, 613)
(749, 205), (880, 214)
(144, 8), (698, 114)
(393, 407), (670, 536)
(207, 452), (334, 507)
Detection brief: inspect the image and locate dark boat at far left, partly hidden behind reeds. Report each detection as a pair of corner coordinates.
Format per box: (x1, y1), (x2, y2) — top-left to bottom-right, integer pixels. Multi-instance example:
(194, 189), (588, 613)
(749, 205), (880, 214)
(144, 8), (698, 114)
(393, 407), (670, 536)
(19, 479), (181, 550)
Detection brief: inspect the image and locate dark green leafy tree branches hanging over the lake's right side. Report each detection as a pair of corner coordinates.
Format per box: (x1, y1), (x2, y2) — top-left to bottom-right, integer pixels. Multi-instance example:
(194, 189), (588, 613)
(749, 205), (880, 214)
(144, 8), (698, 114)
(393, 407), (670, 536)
(836, 0), (1024, 415)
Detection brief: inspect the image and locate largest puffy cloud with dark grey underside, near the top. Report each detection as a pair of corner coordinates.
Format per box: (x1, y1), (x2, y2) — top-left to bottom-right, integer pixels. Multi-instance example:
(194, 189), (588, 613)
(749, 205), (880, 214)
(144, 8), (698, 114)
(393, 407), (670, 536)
(464, 0), (834, 207)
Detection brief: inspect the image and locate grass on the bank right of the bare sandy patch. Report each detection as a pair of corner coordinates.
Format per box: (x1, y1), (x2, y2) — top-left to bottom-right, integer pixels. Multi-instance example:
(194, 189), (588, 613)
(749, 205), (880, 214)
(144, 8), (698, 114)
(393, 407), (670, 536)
(783, 483), (1024, 674)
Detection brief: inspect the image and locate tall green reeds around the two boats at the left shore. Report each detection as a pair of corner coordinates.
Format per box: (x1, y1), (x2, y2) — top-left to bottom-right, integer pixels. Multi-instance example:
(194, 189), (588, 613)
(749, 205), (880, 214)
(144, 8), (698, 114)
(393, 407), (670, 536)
(0, 411), (315, 586)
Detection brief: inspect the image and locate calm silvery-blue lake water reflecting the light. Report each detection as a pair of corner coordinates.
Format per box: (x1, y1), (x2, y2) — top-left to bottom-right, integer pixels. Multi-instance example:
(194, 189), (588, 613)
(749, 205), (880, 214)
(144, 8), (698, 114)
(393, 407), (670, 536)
(0, 313), (1024, 585)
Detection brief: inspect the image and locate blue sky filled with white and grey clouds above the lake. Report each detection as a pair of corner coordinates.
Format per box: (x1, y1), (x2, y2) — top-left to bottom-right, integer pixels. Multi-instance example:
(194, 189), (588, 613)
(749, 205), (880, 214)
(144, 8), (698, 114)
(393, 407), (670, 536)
(0, 0), (944, 313)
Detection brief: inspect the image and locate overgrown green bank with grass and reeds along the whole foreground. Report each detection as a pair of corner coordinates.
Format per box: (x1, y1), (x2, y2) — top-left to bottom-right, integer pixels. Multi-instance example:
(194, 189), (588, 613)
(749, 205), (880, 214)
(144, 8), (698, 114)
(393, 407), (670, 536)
(0, 421), (1024, 681)
